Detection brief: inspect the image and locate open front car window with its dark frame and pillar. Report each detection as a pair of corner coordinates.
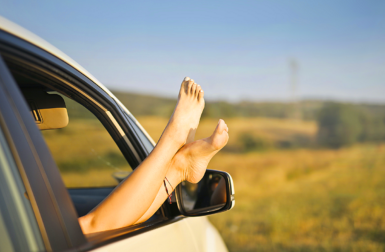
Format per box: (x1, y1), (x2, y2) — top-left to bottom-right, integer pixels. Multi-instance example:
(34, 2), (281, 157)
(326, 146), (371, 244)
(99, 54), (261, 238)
(0, 31), (170, 251)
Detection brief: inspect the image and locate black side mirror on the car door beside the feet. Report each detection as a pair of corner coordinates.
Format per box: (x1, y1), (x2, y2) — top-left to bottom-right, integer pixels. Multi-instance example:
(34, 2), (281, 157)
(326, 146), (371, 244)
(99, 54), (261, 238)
(176, 170), (235, 216)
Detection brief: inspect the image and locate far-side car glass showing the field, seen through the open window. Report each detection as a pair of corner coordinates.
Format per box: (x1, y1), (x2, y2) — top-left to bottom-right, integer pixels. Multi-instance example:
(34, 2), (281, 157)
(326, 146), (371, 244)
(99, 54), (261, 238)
(41, 92), (132, 188)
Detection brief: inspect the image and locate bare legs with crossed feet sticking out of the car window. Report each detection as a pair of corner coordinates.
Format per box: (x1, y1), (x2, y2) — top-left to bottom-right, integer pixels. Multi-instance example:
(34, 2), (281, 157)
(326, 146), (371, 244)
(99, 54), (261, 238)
(79, 77), (228, 234)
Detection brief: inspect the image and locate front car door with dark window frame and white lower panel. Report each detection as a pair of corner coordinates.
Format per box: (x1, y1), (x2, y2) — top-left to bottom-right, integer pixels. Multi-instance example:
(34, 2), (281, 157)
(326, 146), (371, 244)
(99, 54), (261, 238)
(0, 29), (201, 251)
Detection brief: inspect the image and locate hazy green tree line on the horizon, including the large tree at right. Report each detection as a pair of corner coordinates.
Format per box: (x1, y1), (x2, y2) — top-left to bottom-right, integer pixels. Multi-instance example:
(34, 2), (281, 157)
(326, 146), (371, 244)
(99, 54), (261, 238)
(113, 91), (385, 148)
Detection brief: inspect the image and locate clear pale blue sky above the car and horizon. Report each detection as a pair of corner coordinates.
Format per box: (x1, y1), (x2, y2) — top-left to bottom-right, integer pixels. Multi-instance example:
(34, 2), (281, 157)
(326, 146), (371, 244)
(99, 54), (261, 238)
(0, 0), (385, 103)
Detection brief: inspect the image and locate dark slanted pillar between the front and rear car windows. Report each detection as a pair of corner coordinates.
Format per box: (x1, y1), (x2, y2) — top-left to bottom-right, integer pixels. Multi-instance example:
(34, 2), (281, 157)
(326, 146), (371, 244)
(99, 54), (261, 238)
(0, 53), (85, 250)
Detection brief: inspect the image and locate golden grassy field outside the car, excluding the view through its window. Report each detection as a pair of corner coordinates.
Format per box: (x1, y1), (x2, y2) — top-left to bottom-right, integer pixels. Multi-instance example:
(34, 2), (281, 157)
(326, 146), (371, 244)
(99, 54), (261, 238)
(138, 117), (385, 251)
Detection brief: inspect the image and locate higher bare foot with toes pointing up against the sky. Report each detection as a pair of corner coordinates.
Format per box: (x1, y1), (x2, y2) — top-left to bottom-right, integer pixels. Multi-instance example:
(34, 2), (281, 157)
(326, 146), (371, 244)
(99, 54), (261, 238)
(161, 77), (205, 148)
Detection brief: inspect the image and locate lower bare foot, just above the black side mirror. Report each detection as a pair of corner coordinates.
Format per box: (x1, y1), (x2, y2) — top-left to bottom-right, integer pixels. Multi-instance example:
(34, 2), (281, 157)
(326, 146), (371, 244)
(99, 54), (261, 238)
(173, 119), (229, 183)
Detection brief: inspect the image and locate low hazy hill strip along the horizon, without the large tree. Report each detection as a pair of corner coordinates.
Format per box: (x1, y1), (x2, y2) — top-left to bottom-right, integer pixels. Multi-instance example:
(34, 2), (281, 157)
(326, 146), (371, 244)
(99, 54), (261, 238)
(112, 91), (385, 120)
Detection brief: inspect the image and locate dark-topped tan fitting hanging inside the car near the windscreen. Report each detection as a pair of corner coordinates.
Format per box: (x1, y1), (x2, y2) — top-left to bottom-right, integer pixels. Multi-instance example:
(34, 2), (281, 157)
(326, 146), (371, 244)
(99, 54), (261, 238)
(22, 88), (68, 130)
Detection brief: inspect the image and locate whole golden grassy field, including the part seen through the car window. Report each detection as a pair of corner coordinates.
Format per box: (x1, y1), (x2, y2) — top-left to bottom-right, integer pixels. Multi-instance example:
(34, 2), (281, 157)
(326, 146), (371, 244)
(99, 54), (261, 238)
(42, 114), (385, 252)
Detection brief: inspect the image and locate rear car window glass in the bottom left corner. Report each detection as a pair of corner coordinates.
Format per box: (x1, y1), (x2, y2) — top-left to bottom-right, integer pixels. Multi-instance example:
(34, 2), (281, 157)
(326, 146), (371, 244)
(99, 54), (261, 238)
(0, 130), (45, 251)
